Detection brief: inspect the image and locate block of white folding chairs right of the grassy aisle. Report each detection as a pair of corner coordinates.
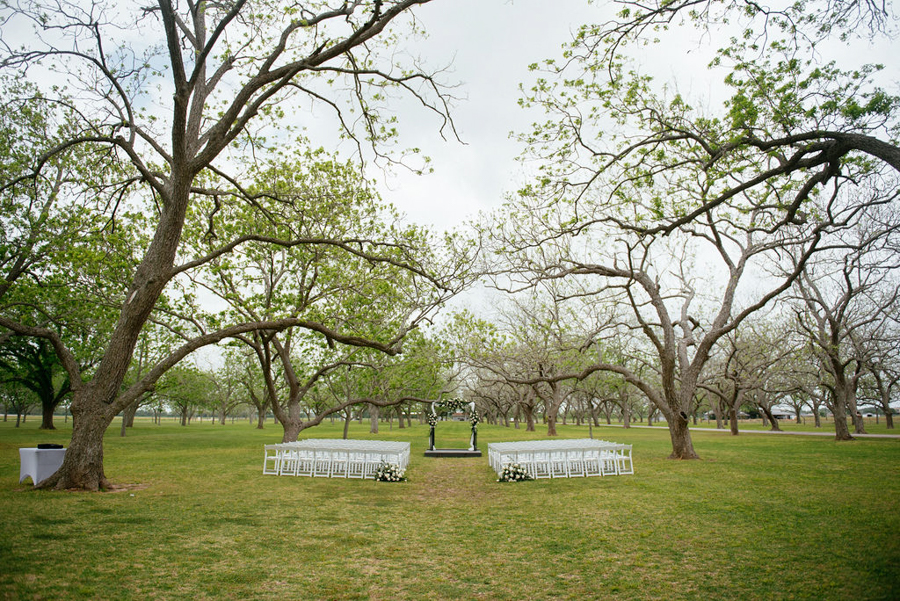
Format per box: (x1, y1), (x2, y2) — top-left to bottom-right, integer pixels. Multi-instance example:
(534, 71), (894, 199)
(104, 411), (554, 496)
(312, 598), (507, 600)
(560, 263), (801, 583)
(488, 438), (634, 478)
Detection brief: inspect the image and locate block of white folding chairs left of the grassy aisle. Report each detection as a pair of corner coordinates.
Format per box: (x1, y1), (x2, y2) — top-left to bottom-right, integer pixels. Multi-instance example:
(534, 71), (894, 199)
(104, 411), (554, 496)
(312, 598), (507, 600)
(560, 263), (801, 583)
(263, 438), (409, 478)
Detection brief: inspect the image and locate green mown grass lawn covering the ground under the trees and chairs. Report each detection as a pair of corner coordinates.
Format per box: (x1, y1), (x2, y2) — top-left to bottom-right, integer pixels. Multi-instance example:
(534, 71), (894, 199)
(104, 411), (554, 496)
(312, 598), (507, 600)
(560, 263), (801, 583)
(0, 420), (900, 601)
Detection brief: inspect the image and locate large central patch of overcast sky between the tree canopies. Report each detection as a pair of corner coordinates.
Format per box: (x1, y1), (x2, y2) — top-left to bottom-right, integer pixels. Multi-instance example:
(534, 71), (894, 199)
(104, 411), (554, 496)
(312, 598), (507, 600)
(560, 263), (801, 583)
(370, 0), (606, 229)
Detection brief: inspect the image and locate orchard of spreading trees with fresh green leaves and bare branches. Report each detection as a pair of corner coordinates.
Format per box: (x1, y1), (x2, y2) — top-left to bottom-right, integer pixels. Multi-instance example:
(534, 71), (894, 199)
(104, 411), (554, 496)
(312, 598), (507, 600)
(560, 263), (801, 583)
(0, 0), (900, 490)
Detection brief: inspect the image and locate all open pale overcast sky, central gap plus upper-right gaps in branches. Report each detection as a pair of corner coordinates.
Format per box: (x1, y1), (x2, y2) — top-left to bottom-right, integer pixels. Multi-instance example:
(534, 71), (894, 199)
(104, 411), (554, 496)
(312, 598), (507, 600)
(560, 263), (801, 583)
(368, 0), (900, 230)
